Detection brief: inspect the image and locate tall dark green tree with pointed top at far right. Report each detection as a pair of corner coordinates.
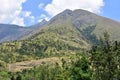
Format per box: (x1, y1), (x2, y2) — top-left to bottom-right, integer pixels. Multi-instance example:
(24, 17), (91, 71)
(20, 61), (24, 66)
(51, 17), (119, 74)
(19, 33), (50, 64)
(90, 32), (120, 80)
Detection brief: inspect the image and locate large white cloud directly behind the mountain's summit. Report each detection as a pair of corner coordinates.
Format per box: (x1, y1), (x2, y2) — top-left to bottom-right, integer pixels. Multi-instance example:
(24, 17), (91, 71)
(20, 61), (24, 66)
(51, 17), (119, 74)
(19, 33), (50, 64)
(45, 0), (104, 16)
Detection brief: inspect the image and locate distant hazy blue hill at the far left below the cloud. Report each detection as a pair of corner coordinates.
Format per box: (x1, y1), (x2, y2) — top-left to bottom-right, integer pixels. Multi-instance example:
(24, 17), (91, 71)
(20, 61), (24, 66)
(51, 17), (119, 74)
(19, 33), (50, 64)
(0, 24), (32, 42)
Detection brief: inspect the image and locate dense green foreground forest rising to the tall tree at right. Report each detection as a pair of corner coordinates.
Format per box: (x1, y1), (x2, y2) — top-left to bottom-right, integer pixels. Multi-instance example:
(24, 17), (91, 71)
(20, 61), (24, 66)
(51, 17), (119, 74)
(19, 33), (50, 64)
(0, 33), (120, 80)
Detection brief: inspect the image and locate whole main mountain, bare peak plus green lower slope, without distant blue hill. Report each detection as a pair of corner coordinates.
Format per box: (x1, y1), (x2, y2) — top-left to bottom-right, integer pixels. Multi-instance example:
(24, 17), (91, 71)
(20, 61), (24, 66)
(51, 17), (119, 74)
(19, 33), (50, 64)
(0, 9), (120, 62)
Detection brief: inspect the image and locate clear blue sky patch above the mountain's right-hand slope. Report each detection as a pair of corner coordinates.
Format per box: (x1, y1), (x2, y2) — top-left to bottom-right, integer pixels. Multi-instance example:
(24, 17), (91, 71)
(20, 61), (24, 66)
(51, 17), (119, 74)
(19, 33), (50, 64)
(100, 0), (120, 22)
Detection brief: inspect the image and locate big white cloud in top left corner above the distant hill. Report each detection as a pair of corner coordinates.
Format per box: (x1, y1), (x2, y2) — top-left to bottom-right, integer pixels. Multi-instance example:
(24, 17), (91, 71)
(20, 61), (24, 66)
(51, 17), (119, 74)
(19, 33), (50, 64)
(0, 0), (34, 26)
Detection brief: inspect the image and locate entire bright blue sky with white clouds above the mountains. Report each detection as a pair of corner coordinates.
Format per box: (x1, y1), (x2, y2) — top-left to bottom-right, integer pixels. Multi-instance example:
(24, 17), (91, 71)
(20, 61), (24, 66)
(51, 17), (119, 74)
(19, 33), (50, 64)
(0, 0), (120, 26)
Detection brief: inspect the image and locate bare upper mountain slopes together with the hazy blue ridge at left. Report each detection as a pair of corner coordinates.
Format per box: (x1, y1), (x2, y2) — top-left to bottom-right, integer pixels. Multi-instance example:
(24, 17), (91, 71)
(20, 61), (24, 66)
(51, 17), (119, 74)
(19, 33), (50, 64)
(0, 9), (120, 42)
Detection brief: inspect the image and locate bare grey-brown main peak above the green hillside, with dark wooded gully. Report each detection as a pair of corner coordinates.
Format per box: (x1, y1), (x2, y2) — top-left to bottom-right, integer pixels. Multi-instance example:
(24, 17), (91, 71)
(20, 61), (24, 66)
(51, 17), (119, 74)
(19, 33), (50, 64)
(49, 9), (120, 40)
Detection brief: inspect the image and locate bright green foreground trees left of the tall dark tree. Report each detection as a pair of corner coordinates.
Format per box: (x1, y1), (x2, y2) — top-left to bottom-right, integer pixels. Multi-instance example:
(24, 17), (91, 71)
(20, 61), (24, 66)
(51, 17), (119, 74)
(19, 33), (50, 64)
(1, 54), (91, 80)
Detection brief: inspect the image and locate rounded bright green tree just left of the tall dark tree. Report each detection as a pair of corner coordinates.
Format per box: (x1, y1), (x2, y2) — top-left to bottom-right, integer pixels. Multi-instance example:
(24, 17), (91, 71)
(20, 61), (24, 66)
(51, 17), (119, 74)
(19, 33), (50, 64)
(62, 53), (91, 80)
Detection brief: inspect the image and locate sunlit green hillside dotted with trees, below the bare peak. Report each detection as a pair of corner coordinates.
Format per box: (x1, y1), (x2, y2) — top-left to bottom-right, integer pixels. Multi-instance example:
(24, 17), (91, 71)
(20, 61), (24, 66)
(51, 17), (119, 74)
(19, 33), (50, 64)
(0, 19), (90, 62)
